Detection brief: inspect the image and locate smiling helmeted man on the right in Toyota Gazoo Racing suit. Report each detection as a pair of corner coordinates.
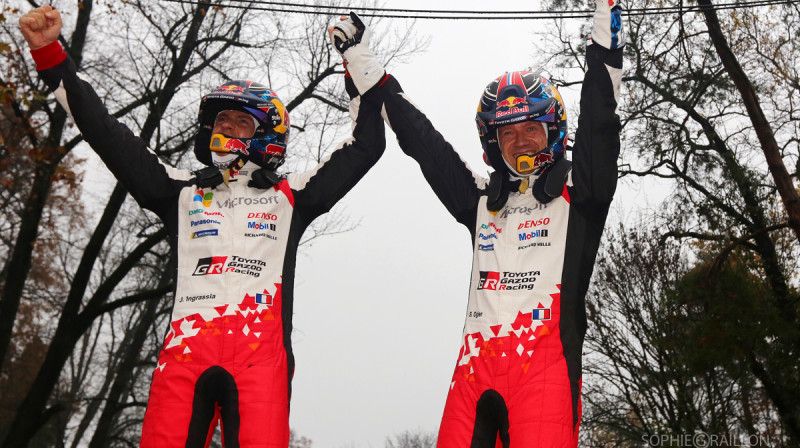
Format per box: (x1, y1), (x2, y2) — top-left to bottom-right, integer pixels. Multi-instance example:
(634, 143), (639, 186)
(337, 0), (624, 448)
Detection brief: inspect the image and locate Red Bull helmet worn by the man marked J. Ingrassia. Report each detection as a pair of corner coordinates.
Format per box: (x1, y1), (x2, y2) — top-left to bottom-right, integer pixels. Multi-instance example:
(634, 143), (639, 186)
(194, 81), (289, 171)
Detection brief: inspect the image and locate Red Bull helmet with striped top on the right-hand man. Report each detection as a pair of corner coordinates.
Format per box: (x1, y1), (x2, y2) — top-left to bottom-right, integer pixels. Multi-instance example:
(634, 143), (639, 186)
(475, 71), (568, 171)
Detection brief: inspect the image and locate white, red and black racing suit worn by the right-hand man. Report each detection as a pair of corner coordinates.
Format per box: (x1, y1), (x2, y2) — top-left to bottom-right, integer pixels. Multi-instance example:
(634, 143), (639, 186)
(372, 45), (622, 448)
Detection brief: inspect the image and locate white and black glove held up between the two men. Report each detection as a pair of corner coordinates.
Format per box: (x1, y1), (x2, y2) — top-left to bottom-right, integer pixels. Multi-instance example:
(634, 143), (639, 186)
(330, 11), (386, 95)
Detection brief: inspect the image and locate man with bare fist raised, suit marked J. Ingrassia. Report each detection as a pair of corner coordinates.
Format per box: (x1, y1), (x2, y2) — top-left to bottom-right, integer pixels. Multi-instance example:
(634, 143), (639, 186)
(20, 6), (385, 448)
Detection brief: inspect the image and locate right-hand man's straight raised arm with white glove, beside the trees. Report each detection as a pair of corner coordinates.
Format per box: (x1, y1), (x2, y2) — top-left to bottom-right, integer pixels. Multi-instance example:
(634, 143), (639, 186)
(572, 0), (625, 206)
